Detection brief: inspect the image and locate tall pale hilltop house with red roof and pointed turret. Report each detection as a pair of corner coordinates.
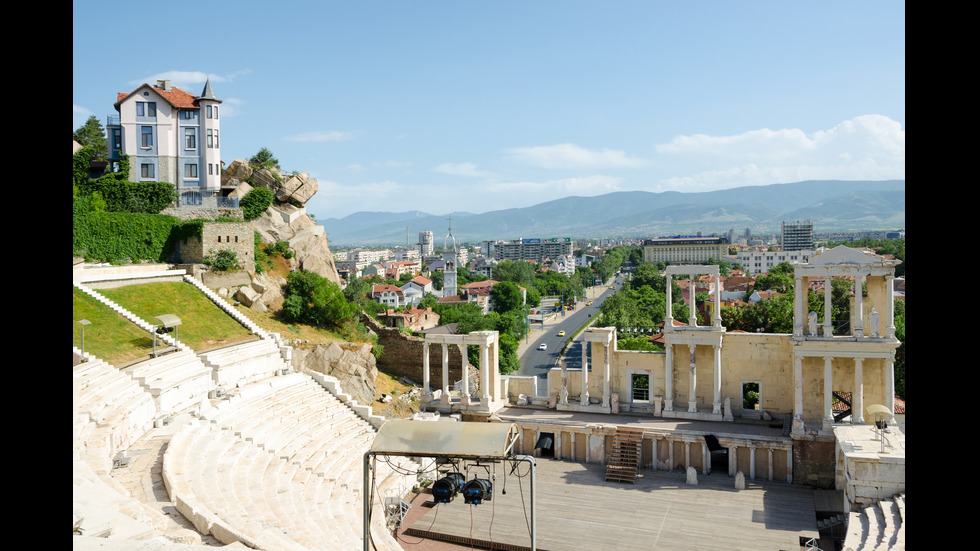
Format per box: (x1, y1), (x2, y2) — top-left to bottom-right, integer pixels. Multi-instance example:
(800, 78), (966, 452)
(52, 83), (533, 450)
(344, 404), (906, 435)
(106, 80), (222, 206)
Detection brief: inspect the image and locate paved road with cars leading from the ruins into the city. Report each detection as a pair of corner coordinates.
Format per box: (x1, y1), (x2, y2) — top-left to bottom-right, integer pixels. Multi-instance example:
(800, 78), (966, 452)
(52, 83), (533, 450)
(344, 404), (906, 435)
(517, 278), (621, 394)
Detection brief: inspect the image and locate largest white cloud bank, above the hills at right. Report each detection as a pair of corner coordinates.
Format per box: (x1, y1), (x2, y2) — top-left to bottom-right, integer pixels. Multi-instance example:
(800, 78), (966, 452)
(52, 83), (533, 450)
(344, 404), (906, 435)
(655, 115), (905, 191)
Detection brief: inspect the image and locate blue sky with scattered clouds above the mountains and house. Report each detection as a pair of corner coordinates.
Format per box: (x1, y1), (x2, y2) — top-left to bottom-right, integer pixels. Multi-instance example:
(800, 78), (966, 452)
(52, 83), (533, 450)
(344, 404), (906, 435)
(72, 0), (905, 219)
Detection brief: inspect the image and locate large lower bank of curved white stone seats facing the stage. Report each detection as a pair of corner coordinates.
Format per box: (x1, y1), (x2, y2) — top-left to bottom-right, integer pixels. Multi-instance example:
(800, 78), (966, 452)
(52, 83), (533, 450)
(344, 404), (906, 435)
(164, 374), (412, 549)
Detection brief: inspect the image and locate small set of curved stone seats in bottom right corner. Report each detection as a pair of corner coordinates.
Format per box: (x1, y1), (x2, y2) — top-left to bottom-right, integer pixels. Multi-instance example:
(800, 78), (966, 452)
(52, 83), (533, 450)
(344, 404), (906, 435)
(844, 493), (905, 551)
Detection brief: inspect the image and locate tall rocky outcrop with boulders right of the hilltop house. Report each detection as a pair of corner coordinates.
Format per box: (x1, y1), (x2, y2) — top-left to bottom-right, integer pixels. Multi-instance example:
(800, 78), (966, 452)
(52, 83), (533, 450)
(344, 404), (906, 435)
(221, 159), (340, 283)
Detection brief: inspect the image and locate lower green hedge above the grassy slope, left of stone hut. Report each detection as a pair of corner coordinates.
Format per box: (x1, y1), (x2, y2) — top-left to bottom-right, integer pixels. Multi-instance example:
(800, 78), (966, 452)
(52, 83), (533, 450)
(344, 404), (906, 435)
(72, 212), (203, 262)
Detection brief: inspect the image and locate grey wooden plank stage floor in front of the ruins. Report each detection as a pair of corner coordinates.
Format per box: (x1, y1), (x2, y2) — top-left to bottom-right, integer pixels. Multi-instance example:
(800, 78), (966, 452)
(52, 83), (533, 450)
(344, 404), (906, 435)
(401, 459), (818, 551)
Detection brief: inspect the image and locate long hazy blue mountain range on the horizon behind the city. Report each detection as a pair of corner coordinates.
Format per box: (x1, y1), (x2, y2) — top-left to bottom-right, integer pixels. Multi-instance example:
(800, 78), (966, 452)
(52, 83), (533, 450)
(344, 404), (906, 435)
(319, 180), (905, 247)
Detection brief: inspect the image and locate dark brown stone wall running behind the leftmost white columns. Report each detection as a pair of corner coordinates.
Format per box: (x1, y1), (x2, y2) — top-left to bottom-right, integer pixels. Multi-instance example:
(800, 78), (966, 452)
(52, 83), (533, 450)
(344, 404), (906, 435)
(364, 316), (462, 390)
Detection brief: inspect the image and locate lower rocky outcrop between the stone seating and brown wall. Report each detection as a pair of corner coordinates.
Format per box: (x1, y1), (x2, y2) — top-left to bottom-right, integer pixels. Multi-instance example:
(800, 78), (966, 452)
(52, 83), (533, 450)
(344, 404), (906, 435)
(293, 343), (378, 405)
